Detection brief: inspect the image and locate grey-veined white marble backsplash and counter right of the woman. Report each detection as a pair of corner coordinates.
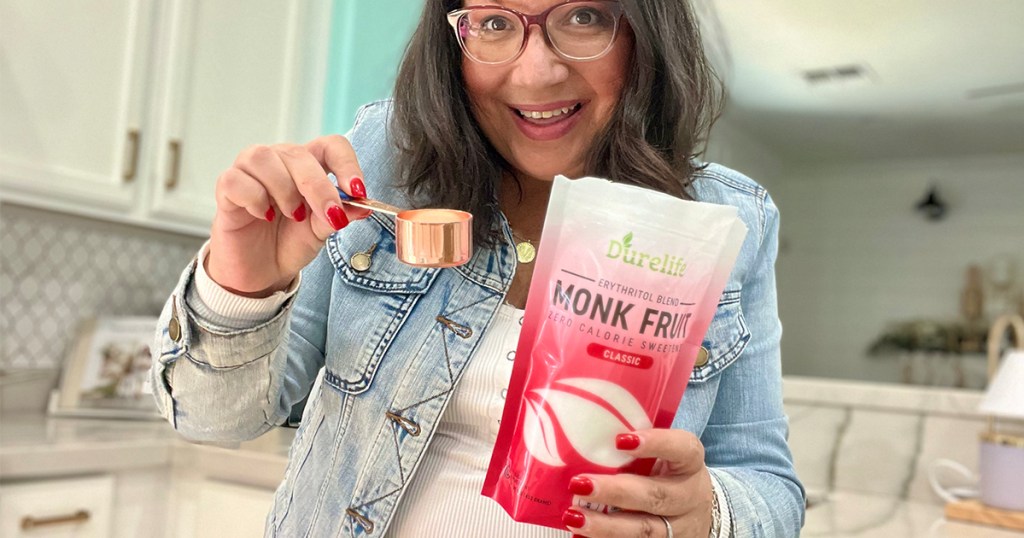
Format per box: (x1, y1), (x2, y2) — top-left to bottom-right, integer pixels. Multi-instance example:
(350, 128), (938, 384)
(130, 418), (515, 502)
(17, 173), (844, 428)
(783, 377), (1024, 538)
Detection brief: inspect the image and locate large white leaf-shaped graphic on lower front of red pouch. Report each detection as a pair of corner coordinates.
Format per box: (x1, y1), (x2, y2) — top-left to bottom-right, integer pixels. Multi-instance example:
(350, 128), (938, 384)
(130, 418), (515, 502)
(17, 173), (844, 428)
(523, 377), (651, 467)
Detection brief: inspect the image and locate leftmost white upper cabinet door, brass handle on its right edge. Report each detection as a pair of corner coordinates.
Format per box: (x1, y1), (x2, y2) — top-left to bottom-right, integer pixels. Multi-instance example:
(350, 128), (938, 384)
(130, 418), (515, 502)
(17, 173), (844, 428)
(0, 0), (153, 210)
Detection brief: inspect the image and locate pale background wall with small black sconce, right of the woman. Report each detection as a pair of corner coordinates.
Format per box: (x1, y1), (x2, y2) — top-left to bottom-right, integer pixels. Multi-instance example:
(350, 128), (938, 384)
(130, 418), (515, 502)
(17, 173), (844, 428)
(771, 155), (1024, 382)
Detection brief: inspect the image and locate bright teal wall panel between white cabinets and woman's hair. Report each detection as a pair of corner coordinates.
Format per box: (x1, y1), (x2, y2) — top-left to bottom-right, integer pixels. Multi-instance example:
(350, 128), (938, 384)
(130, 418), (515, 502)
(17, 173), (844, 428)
(324, 0), (429, 133)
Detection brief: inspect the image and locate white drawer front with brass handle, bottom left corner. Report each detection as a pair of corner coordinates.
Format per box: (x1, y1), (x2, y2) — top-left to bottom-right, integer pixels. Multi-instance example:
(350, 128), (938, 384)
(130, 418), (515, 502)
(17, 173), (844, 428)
(0, 475), (114, 538)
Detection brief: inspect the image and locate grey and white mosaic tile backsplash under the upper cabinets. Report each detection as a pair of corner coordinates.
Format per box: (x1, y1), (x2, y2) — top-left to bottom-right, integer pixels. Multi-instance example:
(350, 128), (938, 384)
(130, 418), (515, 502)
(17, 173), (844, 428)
(0, 204), (203, 370)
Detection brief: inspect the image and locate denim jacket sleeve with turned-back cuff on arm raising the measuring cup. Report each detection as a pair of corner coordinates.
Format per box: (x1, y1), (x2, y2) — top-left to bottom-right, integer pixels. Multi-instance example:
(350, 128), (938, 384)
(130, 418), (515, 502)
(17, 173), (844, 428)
(151, 249), (334, 442)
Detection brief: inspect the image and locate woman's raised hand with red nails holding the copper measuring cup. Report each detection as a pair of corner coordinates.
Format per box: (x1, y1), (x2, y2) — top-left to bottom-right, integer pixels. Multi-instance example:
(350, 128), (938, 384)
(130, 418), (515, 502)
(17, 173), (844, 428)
(206, 135), (369, 297)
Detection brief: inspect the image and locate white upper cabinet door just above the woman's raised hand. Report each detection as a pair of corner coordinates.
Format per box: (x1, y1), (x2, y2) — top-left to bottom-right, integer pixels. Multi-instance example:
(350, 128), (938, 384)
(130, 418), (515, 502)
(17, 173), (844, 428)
(152, 0), (321, 226)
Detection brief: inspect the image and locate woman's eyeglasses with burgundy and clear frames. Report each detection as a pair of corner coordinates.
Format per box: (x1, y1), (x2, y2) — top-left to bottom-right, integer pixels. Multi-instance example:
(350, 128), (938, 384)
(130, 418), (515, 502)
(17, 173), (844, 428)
(447, 0), (623, 65)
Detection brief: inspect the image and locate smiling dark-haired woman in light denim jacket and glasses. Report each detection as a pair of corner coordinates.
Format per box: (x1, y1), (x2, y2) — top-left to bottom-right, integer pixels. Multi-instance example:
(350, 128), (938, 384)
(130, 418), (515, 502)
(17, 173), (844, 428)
(154, 0), (804, 538)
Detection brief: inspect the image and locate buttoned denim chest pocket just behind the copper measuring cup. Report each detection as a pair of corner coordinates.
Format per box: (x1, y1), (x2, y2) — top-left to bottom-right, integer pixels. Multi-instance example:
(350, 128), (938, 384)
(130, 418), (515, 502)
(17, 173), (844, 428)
(324, 215), (438, 395)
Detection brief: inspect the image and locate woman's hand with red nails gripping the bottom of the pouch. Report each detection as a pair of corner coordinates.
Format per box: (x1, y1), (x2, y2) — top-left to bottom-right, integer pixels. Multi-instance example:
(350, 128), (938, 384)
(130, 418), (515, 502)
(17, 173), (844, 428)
(562, 429), (714, 538)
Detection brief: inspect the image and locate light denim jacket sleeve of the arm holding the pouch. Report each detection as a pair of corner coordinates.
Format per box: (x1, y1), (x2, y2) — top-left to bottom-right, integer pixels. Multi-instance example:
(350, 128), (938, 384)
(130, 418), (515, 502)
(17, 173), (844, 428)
(701, 190), (805, 538)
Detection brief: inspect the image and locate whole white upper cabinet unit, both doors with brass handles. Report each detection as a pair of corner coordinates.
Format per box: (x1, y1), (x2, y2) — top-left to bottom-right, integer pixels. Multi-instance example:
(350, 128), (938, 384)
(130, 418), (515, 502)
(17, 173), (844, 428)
(0, 0), (330, 235)
